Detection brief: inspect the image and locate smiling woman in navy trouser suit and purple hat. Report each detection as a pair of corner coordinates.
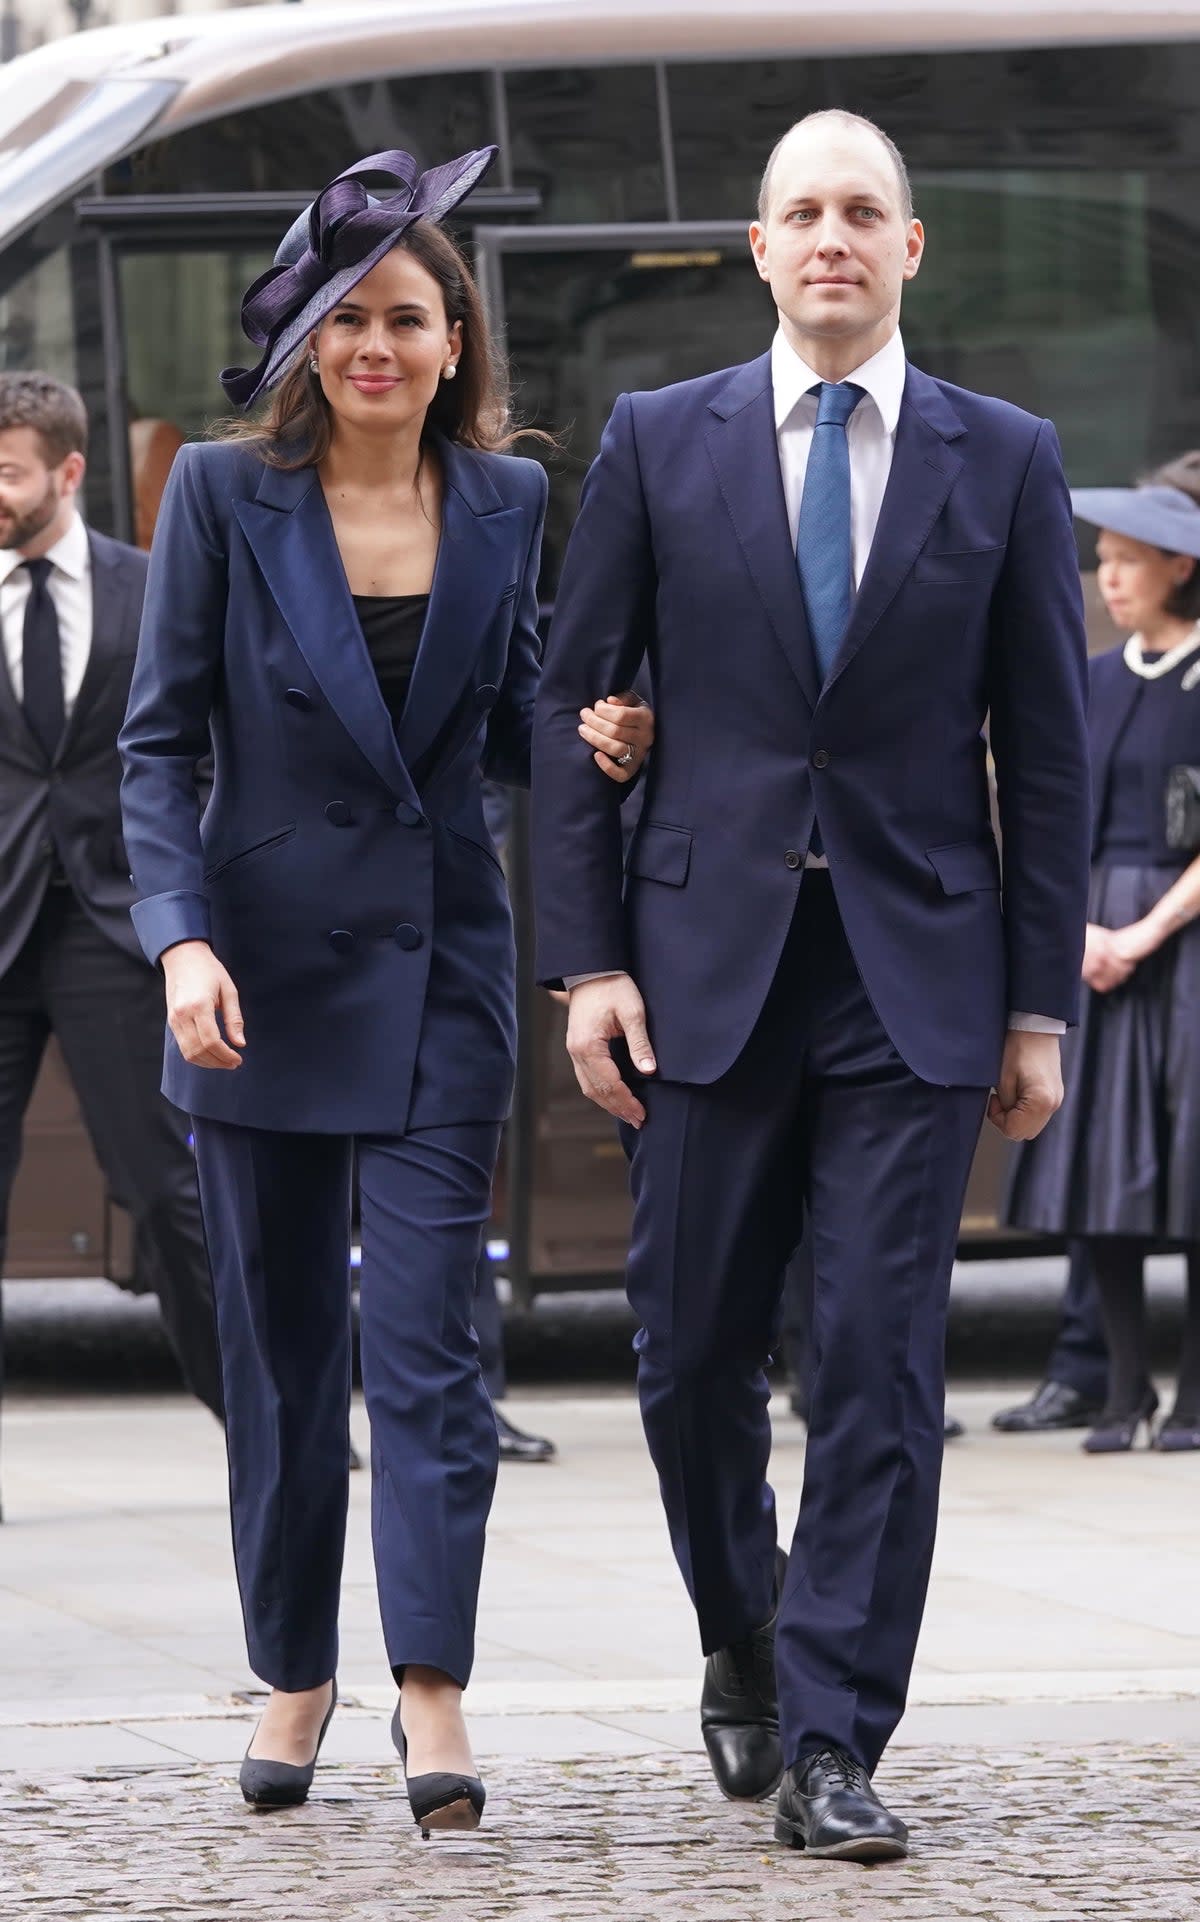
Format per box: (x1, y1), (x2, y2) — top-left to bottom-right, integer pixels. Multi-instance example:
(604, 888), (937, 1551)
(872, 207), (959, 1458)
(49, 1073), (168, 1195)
(121, 148), (652, 1834)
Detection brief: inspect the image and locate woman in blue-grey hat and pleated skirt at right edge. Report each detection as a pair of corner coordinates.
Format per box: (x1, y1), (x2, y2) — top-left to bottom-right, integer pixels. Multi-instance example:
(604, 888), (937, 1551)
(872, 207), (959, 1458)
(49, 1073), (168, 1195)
(1010, 454), (1200, 1455)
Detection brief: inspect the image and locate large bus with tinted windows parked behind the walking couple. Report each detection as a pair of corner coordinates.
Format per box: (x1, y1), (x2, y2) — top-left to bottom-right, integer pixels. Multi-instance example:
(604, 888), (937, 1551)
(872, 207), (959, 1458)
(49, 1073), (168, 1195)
(0, 0), (1200, 1294)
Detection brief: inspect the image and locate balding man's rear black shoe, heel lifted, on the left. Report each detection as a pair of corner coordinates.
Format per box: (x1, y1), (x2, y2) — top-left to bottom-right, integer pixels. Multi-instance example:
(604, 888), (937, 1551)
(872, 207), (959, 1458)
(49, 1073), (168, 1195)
(700, 1549), (787, 1801)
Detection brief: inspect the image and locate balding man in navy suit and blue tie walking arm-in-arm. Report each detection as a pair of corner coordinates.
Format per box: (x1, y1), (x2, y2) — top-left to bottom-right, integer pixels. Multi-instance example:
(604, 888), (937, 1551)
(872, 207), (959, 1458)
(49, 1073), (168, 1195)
(533, 113), (1088, 1860)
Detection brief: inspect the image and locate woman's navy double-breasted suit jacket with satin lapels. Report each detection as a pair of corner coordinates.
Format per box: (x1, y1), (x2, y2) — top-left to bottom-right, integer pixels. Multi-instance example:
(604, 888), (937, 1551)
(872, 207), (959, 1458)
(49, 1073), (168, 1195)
(121, 428), (550, 1134)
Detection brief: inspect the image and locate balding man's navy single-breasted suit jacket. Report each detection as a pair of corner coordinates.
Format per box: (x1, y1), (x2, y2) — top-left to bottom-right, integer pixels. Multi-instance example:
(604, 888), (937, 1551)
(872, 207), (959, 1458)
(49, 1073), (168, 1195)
(533, 356), (1090, 1086)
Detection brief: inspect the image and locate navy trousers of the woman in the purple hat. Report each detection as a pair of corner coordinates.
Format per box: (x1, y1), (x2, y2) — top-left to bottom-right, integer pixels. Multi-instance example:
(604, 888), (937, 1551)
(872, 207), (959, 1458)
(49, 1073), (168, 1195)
(194, 1119), (500, 1689)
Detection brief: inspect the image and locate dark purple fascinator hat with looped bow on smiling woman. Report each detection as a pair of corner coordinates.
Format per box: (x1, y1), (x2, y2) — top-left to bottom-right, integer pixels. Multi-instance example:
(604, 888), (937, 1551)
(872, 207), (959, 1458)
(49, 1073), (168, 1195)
(221, 146), (498, 407)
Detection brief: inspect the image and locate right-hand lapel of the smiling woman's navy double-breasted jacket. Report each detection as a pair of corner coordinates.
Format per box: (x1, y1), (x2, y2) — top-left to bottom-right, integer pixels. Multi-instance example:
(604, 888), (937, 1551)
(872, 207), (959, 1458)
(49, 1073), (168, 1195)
(398, 436), (521, 769)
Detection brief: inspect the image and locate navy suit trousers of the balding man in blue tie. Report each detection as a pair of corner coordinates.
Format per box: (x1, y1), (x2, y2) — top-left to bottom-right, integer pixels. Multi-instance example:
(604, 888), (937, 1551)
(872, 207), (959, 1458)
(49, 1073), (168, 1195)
(627, 873), (987, 1770)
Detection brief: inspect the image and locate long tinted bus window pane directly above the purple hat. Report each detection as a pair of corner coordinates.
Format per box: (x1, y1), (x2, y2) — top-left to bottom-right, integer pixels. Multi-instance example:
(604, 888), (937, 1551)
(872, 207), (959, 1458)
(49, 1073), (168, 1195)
(106, 73), (494, 194)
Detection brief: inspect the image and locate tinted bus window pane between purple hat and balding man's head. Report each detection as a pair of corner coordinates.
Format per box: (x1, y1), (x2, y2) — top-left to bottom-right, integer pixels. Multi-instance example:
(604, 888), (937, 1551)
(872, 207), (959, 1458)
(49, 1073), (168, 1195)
(504, 67), (667, 223)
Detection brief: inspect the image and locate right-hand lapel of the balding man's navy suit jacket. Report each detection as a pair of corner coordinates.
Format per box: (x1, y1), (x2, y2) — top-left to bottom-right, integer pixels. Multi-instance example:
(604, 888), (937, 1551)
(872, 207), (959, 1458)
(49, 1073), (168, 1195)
(825, 367), (965, 688)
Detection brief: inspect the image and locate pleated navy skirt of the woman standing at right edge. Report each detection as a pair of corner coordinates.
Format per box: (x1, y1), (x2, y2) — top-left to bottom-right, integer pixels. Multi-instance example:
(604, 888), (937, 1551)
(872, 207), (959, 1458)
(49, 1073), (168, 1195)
(1006, 867), (1200, 1247)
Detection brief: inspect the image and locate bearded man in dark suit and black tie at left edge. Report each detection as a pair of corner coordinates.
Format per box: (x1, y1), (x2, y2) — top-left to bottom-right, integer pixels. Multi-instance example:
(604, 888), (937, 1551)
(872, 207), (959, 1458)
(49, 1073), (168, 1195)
(0, 373), (221, 1460)
